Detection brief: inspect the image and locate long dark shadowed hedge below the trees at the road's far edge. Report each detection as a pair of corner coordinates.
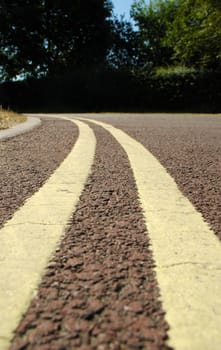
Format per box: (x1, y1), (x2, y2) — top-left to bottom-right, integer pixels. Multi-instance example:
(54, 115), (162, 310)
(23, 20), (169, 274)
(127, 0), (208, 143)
(0, 69), (221, 113)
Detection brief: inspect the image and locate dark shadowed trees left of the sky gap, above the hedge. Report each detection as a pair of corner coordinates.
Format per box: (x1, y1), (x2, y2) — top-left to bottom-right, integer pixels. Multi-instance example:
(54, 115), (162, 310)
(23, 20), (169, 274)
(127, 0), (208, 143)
(0, 0), (112, 79)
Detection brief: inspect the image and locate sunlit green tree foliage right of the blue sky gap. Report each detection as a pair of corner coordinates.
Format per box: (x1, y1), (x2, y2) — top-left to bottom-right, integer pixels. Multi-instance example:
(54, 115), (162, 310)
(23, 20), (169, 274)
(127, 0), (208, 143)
(131, 0), (221, 69)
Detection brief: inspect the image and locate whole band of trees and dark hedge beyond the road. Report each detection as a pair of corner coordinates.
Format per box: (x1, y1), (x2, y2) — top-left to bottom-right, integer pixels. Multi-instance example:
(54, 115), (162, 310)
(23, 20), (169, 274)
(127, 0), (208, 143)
(0, 0), (221, 112)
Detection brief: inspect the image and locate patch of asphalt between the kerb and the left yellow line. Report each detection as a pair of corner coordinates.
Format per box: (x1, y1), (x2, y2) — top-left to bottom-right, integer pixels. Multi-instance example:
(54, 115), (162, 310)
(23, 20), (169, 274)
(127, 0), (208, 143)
(0, 119), (78, 227)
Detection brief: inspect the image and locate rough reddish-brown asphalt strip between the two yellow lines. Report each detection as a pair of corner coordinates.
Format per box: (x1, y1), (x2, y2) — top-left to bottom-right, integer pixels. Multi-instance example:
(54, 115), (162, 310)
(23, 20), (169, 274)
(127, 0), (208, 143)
(8, 123), (168, 350)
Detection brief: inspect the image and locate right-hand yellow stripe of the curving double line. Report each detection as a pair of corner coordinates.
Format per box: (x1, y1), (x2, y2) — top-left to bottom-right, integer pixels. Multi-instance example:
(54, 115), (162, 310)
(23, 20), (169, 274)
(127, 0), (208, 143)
(84, 119), (221, 350)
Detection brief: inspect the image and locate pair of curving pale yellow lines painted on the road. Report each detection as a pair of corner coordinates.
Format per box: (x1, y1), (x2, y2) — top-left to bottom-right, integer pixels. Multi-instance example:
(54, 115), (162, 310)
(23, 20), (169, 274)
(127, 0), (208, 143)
(0, 119), (221, 350)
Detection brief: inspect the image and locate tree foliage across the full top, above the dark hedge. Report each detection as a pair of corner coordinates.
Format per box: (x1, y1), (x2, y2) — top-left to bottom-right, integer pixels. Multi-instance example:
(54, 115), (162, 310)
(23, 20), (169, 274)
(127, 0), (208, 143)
(0, 0), (221, 80)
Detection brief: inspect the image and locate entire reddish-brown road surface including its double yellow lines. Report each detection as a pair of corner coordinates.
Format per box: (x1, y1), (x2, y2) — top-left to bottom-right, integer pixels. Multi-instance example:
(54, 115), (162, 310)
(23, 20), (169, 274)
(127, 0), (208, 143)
(0, 114), (221, 350)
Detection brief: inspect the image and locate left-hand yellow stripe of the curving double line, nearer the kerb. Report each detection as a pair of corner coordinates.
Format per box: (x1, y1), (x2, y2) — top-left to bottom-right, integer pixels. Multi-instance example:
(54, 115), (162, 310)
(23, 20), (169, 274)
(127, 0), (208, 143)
(0, 121), (96, 350)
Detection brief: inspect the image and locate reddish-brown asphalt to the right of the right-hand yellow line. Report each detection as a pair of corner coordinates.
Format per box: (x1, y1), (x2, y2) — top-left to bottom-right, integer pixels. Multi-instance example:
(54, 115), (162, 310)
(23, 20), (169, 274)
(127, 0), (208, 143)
(99, 115), (221, 239)
